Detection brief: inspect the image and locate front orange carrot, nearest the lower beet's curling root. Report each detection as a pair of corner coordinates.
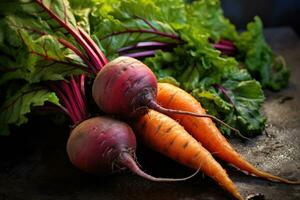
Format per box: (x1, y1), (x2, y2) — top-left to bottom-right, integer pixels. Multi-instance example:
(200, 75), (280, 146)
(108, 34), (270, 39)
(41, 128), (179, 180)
(133, 109), (243, 199)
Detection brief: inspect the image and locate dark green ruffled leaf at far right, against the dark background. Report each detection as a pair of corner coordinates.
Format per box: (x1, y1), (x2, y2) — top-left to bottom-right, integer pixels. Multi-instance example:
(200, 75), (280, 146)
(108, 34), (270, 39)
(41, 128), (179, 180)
(236, 17), (290, 90)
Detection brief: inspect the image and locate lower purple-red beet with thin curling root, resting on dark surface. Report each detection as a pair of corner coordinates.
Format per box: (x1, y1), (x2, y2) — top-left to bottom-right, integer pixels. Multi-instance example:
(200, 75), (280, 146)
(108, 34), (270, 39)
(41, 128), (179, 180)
(67, 117), (197, 182)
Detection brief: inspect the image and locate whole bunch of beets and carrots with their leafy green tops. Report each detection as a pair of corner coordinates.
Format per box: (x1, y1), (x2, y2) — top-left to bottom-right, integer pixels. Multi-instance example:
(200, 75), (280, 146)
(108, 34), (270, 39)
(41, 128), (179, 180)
(0, 0), (299, 199)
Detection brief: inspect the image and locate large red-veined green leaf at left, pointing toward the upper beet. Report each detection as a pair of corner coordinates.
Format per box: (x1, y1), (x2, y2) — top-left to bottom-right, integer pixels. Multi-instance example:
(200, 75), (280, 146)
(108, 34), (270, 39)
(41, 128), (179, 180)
(0, 15), (86, 85)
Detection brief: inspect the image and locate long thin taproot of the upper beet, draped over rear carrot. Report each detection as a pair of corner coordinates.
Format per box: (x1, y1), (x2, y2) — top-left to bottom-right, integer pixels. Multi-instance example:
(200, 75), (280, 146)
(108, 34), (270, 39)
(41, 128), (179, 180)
(148, 101), (251, 140)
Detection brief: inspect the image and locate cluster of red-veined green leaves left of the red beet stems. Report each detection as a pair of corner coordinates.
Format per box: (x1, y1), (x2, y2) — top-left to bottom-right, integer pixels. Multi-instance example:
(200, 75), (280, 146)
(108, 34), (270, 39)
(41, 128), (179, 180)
(0, 0), (87, 135)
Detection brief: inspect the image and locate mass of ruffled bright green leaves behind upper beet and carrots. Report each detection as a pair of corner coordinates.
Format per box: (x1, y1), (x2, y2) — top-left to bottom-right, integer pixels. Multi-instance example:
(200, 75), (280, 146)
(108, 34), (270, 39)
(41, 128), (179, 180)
(84, 0), (288, 135)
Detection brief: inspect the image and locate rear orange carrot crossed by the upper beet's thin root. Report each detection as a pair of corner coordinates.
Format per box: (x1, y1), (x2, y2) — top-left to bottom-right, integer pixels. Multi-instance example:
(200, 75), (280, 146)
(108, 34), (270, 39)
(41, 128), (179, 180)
(157, 83), (300, 184)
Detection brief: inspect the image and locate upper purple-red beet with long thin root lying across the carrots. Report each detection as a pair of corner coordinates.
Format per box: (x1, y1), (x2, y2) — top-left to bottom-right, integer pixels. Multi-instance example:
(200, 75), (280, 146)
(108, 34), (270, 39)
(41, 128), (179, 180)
(92, 56), (239, 133)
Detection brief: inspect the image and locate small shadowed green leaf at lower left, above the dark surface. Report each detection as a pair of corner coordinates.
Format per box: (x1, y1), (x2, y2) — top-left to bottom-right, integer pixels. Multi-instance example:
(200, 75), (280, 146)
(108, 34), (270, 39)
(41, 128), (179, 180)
(0, 85), (59, 135)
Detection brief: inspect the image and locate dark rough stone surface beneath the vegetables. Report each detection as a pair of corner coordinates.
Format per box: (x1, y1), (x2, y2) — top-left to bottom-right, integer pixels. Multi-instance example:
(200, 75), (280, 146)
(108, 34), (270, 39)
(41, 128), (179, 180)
(0, 28), (300, 200)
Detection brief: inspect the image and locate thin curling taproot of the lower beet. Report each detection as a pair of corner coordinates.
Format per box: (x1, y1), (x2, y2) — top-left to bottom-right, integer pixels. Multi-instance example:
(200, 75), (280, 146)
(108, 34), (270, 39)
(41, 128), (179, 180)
(119, 152), (200, 182)
